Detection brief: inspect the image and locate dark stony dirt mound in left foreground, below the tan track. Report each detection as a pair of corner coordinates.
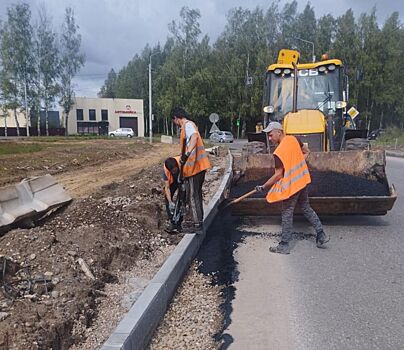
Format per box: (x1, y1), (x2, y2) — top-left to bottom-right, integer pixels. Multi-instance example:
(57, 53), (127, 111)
(0, 165), (180, 349)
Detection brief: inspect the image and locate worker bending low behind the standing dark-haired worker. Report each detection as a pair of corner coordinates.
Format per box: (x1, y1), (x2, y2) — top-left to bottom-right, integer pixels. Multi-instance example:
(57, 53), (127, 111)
(163, 156), (182, 233)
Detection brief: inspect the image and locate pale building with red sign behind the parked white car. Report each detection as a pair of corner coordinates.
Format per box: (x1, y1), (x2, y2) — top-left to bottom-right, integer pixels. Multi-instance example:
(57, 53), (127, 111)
(68, 97), (144, 137)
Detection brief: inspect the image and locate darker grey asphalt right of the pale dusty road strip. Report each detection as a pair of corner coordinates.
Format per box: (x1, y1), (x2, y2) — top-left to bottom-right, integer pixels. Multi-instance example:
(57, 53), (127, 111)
(284, 158), (404, 350)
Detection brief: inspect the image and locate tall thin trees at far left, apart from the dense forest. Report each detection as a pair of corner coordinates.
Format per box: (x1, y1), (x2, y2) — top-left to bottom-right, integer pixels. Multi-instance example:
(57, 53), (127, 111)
(0, 3), (84, 135)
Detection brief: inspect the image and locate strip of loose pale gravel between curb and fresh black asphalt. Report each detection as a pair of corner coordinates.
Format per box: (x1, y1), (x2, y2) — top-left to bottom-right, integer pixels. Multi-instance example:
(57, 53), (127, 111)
(149, 263), (223, 350)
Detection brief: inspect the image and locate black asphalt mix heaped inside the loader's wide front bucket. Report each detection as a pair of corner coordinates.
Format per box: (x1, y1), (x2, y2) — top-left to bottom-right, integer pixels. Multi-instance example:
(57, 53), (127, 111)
(230, 171), (389, 198)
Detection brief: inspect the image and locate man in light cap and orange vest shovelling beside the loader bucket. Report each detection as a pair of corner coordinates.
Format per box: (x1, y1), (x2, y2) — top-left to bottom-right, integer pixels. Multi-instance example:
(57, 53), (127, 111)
(255, 122), (329, 254)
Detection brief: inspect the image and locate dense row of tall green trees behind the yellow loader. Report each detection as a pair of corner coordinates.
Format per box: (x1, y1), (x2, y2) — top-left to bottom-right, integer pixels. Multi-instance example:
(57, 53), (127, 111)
(100, 1), (404, 135)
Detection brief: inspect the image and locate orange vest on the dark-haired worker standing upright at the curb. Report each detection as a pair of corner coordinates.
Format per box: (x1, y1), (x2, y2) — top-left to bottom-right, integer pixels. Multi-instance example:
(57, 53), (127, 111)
(180, 120), (210, 177)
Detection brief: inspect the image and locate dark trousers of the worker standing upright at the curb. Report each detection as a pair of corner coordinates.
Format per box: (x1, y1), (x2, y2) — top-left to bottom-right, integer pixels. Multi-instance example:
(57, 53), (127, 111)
(185, 171), (206, 224)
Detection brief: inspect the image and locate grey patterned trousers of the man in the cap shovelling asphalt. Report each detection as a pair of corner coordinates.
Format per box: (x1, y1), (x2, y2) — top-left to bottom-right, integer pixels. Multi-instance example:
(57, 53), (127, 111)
(282, 186), (323, 242)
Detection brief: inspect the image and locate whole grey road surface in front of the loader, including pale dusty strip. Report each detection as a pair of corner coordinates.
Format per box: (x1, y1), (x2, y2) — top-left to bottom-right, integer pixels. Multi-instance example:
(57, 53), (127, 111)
(224, 157), (404, 350)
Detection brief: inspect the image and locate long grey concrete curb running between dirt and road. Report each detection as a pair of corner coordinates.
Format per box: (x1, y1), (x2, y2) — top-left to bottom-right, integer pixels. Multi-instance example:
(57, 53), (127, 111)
(101, 152), (233, 350)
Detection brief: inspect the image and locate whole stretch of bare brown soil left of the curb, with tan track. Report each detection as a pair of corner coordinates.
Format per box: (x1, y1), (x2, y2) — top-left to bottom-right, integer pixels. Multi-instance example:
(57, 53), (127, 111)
(0, 140), (224, 350)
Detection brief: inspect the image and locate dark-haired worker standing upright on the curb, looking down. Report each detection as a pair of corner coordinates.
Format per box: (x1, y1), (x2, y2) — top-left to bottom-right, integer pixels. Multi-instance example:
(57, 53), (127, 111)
(171, 107), (210, 231)
